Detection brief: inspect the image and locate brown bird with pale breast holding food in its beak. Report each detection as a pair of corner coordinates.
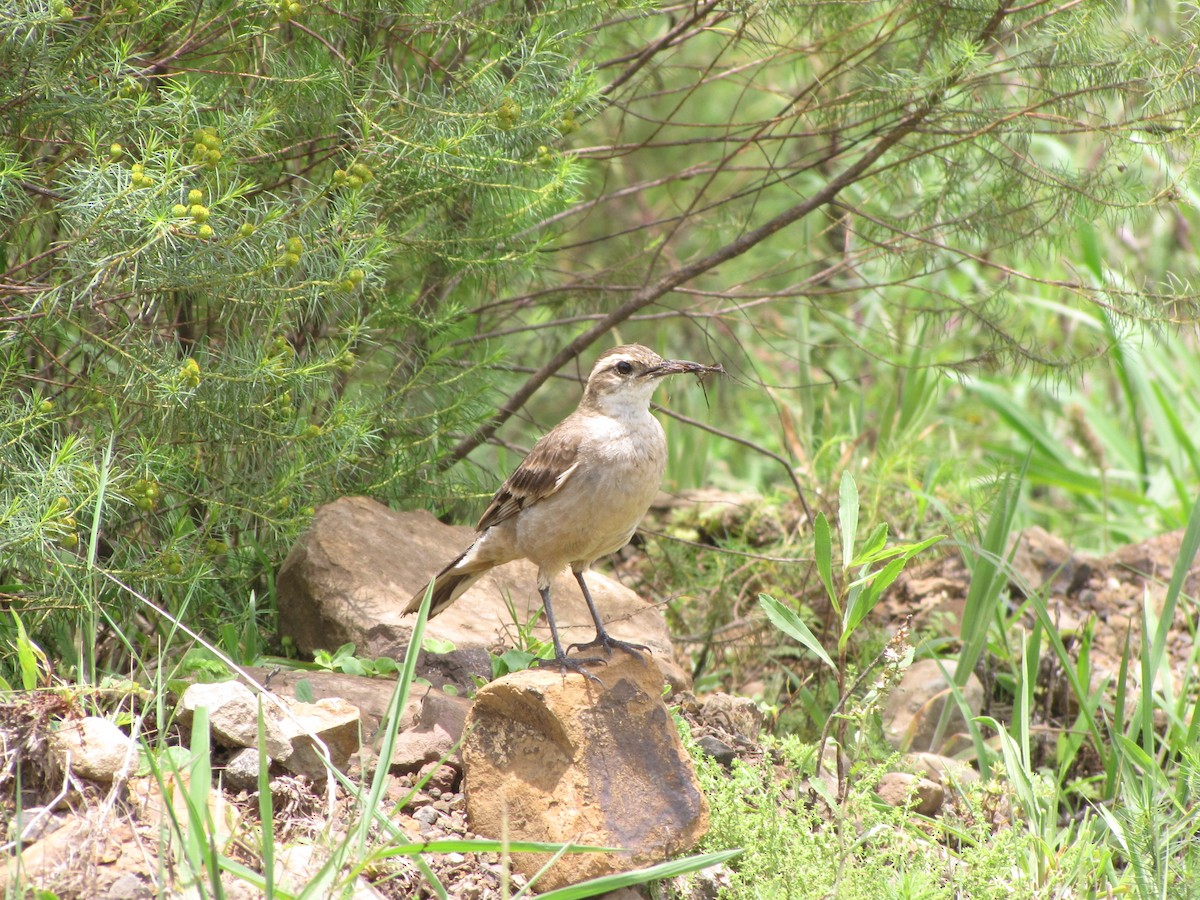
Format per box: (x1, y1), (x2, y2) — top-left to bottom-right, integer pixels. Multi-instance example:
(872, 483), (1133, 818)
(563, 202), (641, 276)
(404, 344), (724, 671)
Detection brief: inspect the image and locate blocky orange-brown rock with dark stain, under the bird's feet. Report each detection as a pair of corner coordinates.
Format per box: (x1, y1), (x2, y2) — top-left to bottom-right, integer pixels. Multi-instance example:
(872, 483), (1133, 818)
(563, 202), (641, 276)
(462, 653), (708, 890)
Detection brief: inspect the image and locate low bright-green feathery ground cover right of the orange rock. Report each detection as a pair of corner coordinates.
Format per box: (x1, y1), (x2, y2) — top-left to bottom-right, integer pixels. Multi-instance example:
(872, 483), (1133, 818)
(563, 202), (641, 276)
(696, 738), (1109, 900)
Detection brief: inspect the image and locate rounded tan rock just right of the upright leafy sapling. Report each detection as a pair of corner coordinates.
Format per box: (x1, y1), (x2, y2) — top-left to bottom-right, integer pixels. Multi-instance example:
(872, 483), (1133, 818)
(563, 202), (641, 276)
(883, 659), (983, 751)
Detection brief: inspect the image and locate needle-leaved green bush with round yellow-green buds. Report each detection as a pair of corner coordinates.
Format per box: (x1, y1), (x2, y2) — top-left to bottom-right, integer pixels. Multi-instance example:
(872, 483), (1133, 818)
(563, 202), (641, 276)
(0, 0), (600, 678)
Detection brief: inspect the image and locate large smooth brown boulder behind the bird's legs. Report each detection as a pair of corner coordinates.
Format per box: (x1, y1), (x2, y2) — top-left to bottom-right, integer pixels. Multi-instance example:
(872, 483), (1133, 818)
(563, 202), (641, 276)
(277, 497), (688, 689)
